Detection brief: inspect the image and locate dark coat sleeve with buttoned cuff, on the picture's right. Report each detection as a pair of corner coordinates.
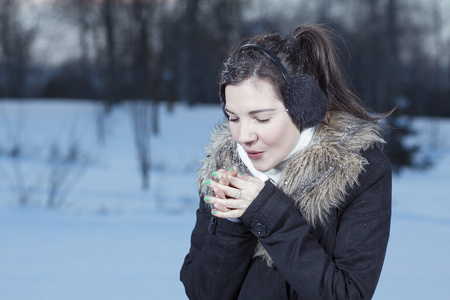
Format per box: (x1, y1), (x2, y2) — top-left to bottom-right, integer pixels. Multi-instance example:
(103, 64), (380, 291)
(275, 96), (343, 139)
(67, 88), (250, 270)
(241, 150), (392, 299)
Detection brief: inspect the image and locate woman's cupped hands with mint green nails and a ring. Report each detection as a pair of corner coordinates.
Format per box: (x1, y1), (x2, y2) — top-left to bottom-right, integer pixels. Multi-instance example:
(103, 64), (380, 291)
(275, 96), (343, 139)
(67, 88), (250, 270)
(205, 167), (264, 218)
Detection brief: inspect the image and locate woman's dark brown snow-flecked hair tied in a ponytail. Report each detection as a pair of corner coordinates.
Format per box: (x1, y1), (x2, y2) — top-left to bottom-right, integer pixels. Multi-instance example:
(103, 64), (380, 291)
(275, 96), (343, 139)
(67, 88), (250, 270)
(219, 24), (379, 121)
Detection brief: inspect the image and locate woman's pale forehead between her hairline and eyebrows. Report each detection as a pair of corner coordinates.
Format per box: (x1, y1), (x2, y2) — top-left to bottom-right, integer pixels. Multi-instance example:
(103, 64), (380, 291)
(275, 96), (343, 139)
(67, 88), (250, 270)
(225, 78), (283, 110)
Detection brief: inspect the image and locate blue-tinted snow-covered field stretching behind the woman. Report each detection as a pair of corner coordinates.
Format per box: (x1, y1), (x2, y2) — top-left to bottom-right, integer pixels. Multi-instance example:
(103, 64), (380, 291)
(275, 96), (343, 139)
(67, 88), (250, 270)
(0, 101), (450, 300)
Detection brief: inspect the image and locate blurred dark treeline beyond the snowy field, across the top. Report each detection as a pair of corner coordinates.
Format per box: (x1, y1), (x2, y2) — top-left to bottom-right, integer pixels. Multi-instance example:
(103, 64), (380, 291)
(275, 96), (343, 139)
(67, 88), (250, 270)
(0, 0), (450, 116)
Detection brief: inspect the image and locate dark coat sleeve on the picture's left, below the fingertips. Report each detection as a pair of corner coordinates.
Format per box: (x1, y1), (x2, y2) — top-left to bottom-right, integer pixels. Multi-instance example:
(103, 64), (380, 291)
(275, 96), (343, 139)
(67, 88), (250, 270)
(180, 200), (256, 300)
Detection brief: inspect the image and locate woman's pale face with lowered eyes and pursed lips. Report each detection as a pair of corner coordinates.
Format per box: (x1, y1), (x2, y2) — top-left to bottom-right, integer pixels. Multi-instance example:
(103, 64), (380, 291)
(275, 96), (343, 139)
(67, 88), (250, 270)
(225, 78), (300, 172)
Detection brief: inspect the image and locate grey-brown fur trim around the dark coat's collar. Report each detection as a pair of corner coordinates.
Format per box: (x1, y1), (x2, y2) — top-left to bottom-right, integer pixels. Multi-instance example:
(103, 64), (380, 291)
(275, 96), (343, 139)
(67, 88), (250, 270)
(198, 112), (385, 265)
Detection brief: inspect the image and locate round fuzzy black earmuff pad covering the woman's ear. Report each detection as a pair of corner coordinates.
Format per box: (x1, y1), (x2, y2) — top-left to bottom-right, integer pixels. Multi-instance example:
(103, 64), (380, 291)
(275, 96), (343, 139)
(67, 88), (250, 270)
(283, 74), (327, 128)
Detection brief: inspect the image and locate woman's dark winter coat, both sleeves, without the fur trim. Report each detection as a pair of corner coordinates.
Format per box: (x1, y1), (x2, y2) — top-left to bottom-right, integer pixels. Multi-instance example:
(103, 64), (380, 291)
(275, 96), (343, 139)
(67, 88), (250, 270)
(181, 147), (391, 300)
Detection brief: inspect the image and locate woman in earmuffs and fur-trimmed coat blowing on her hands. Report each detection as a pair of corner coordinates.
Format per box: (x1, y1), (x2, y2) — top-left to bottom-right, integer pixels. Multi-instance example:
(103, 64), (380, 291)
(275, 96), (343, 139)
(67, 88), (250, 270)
(181, 25), (391, 300)
